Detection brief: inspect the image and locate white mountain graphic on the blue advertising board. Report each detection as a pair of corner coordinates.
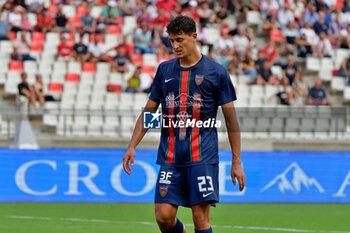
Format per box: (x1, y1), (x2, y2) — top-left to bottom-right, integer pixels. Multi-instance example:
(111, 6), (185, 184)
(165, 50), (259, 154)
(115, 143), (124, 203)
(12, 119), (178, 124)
(260, 162), (325, 194)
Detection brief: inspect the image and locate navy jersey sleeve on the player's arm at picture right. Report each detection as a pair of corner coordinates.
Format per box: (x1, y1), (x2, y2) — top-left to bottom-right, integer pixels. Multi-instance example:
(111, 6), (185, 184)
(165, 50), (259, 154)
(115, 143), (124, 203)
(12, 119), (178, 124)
(218, 66), (237, 105)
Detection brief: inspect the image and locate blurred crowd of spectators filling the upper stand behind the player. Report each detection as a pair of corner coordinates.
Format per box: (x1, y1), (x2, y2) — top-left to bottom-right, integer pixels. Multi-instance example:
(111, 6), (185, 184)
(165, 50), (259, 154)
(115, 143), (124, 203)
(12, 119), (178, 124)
(0, 0), (350, 106)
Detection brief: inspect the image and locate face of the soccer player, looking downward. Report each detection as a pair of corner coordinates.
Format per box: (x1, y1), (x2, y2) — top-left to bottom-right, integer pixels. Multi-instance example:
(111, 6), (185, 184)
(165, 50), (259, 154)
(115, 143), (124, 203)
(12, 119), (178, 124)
(169, 33), (197, 59)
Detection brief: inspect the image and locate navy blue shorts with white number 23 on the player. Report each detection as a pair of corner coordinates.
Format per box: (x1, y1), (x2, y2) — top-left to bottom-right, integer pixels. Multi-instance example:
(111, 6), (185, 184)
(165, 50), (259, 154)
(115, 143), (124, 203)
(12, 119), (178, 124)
(154, 164), (219, 207)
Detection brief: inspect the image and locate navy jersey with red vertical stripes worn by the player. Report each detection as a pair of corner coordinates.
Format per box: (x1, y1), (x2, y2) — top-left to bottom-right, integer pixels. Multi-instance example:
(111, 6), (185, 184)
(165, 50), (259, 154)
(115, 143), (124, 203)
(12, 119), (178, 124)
(149, 55), (236, 166)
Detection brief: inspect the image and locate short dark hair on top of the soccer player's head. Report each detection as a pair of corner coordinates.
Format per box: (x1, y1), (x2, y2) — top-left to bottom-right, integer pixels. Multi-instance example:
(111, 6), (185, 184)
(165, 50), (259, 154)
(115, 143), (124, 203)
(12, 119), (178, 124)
(167, 15), (196, 35)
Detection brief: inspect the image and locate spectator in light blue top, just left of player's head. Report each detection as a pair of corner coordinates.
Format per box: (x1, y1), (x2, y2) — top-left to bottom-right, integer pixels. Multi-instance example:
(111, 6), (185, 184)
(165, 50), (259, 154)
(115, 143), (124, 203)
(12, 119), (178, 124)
(135, 21), (153, 54)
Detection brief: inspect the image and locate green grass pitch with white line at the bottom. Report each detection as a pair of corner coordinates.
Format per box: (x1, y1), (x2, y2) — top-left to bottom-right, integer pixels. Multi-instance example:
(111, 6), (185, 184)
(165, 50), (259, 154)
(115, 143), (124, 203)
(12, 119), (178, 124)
(0, 203), (350, 233)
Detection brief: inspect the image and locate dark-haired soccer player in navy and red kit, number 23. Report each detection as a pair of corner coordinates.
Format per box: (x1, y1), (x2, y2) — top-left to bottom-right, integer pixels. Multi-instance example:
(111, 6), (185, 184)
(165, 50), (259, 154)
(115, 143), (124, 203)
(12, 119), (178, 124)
(123, 16), (245, 233)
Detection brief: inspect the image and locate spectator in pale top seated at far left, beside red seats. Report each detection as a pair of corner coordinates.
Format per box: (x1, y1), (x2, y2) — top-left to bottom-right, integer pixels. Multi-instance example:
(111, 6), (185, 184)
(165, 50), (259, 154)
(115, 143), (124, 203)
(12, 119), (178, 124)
(13, 31), (36, 61)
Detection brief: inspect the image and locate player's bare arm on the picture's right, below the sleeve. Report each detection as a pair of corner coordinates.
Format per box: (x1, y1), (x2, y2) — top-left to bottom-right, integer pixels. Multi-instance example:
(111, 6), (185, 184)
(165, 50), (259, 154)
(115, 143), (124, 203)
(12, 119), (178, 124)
(221, 101), (245, 191)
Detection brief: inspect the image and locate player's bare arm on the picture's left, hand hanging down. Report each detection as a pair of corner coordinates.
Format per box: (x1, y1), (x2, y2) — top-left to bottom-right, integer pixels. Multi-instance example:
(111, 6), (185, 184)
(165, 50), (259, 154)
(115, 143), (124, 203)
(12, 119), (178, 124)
(123, 99), (159, 175)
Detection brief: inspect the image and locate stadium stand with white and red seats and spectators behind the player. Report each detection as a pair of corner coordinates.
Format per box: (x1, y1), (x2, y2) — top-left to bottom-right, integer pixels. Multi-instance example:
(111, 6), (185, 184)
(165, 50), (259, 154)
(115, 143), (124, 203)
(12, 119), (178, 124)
(0, 0), (350, 144)
